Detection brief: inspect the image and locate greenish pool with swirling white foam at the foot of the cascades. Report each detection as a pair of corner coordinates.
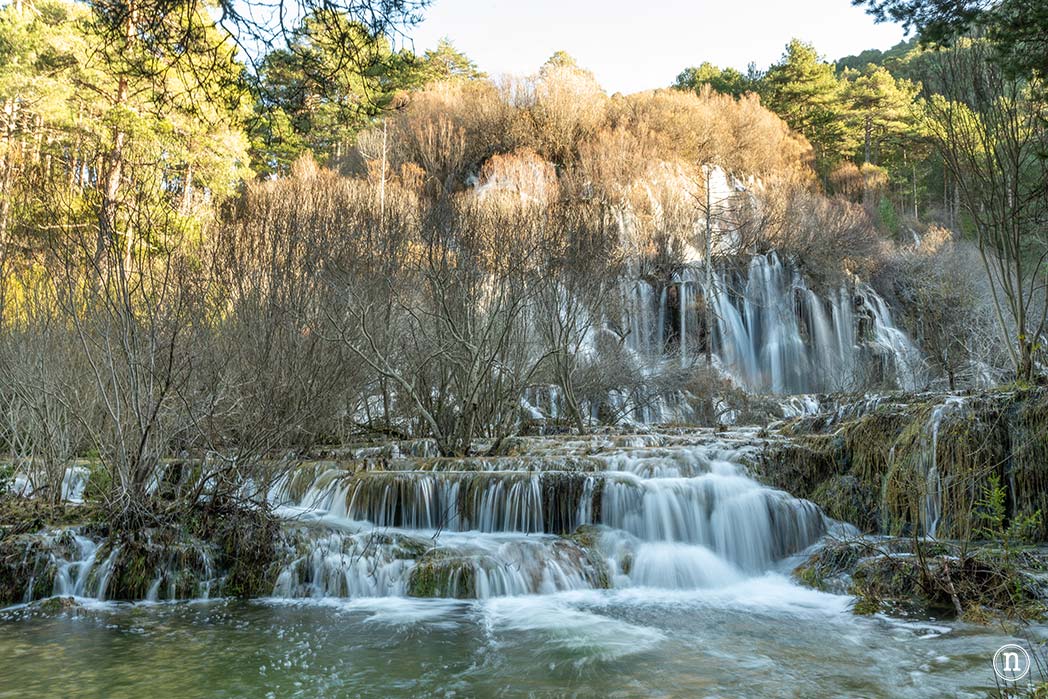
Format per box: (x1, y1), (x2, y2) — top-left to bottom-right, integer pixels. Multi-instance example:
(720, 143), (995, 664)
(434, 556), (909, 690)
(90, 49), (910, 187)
(0, 573), (1031, 699)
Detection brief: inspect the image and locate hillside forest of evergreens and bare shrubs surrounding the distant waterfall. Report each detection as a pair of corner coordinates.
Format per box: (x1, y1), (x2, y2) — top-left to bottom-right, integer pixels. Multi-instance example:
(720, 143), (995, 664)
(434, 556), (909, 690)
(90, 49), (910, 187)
(0, 2), (1048, 486)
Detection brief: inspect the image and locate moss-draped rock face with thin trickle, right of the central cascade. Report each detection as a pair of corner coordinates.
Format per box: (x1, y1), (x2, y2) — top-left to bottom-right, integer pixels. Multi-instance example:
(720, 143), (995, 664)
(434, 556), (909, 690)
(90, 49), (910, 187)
(759, 389), (1048, 541)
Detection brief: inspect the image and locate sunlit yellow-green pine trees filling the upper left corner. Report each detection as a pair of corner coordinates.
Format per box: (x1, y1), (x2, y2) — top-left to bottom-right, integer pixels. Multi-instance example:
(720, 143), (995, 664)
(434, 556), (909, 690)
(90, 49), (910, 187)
(0, 0), (249, 257)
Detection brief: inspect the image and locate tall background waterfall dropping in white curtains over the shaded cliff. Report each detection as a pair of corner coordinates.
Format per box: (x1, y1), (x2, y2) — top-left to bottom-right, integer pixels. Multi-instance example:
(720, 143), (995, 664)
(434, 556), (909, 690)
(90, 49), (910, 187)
(629, 253), (923, 394)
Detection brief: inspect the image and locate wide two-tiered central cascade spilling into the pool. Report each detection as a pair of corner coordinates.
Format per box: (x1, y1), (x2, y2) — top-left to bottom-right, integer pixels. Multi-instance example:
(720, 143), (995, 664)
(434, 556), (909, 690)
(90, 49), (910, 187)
(259, 437), (827, 597)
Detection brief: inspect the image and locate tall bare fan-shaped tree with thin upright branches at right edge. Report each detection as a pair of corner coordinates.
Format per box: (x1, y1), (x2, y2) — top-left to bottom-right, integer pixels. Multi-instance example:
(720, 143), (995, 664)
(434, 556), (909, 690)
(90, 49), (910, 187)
(925, 40), (1048, 379)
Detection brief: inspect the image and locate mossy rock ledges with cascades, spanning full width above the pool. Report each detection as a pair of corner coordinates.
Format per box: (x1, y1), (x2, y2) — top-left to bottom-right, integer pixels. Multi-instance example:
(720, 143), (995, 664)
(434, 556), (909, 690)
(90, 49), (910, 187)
(6, 389), (1048, 618)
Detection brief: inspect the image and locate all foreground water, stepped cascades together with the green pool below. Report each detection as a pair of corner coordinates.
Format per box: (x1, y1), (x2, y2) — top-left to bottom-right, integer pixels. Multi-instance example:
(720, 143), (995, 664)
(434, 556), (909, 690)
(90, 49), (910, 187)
(0, 431), (1039, 698)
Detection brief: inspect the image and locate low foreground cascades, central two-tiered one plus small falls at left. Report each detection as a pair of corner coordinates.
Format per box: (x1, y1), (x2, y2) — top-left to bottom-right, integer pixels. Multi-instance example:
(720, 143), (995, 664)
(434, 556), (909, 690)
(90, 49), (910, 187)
(6, 430), (825, 602)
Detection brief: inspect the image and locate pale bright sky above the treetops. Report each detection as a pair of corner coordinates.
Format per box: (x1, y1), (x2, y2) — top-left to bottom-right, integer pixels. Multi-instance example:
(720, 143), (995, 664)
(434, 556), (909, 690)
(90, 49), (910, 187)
(407, 0), (903, 93)
